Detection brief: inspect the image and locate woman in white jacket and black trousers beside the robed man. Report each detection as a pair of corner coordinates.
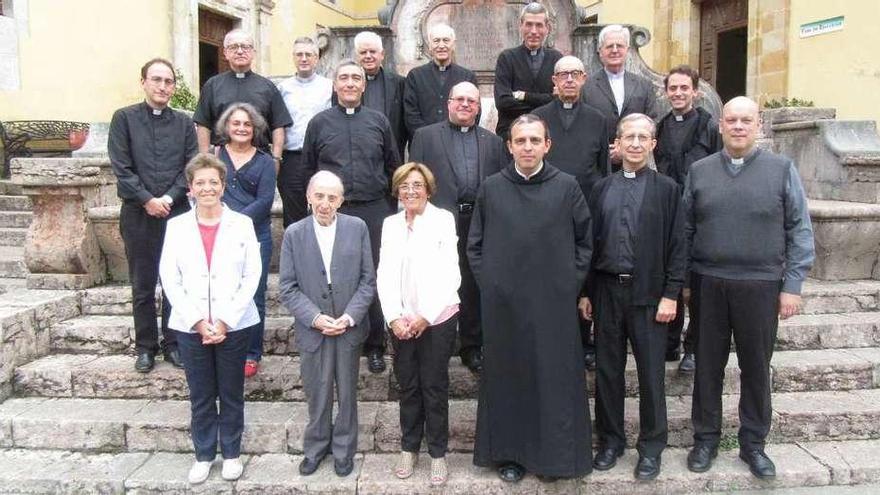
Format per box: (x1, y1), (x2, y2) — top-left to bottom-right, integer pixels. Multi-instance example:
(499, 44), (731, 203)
(376, 162), (461, 485)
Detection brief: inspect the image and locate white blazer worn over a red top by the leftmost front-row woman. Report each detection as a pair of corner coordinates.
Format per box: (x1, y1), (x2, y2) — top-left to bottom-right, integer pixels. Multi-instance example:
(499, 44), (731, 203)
(159, 205), (262, 333)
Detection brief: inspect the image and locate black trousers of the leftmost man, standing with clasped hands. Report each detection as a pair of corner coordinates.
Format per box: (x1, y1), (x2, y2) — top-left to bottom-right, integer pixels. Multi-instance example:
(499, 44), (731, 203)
(119, 201), (189, 354)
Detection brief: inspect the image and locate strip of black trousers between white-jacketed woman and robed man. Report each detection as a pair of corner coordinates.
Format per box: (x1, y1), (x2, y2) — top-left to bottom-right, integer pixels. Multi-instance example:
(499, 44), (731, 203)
(456, 212), (483, 354)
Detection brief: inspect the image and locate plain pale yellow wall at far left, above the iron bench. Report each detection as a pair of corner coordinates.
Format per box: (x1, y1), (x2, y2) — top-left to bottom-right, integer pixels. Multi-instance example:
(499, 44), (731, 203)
(0, 0), (172, 122)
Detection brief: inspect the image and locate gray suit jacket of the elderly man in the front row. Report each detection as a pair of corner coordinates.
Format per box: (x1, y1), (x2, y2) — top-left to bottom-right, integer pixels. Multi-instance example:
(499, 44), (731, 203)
(279, 213), (376, 352)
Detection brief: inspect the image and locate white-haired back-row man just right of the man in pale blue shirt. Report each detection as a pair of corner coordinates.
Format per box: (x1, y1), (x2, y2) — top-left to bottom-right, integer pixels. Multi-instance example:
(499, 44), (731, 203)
(354, 31), (409, 158)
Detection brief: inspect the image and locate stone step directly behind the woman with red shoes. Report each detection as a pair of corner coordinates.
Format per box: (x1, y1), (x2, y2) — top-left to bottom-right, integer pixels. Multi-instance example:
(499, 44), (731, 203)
(49, 312), (880, 354)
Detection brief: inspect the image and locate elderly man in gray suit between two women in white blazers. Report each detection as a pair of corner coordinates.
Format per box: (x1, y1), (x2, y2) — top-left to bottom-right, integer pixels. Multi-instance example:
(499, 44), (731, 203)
(279, 171), (376, 476)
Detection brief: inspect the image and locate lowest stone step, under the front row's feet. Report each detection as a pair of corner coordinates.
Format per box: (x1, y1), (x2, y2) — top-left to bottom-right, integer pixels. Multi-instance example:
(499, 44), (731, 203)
(0, 441), (880, 495)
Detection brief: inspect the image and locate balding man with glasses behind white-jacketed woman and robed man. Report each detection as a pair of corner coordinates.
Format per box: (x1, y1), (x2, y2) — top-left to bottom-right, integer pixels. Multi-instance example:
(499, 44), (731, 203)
(410, 82), (507, 373)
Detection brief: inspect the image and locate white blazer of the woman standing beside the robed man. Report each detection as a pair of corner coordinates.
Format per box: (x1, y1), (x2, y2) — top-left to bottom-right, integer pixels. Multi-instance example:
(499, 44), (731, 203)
(376, 203), (461, 324)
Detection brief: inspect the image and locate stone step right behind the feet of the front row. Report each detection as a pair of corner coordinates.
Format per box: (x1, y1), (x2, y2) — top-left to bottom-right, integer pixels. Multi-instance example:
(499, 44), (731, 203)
(0, 390), (880, 454)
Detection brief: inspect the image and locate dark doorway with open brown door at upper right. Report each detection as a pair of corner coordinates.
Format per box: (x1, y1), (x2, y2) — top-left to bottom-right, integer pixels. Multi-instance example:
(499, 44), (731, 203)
(697, 0), (749, 102)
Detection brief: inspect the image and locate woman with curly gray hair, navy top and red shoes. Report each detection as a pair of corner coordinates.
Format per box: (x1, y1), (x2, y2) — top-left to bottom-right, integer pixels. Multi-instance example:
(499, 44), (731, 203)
(216, 103), (275, 378)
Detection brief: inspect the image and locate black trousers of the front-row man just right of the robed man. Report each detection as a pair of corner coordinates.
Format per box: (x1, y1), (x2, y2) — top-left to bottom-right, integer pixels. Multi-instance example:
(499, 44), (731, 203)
(592, 274), (668, 457)
